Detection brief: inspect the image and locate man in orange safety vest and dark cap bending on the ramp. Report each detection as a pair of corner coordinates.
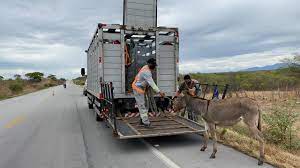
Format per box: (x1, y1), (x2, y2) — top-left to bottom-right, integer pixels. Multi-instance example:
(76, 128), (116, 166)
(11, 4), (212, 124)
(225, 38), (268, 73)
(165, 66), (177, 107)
(131, 58), (165, 127)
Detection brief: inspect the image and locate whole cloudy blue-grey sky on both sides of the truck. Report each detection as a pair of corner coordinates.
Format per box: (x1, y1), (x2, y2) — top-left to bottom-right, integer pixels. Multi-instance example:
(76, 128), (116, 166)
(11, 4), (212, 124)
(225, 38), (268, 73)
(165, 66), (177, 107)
(0, 0), (300, 78)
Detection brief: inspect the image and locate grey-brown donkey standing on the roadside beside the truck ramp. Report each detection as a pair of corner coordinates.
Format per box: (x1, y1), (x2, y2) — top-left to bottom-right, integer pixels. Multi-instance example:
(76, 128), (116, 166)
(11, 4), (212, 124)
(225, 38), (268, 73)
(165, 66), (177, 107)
(173, 94), (264, 165)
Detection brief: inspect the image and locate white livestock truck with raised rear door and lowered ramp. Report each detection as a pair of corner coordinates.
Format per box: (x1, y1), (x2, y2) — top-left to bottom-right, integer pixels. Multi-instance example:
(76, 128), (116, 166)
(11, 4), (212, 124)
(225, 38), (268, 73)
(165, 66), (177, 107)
(82, 0), (204, 139)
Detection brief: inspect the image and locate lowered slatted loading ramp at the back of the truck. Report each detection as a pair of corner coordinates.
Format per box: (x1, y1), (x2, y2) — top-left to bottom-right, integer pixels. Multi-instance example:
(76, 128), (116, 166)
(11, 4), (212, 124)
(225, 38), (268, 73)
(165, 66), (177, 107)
(113, 116), (205, 139)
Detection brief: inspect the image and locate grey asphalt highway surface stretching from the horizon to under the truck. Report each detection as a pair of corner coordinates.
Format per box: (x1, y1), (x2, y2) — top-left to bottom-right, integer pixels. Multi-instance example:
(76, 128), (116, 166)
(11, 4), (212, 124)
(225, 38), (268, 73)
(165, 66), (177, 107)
(0, 84), (271, 168)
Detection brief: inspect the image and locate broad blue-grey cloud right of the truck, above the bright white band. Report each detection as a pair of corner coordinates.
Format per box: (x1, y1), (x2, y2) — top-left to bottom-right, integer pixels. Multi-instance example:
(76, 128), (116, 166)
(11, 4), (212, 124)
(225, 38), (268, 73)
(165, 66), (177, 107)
(159, 0), (300, 60)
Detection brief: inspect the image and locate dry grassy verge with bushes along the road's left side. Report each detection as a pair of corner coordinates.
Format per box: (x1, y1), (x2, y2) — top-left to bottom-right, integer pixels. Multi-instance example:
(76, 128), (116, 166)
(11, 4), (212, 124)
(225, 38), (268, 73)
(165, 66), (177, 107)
(0, 79), (62, 100)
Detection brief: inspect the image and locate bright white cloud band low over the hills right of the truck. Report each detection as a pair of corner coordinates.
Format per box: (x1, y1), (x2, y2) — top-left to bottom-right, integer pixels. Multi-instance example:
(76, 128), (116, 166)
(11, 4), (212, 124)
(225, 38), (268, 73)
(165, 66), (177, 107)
(179, 48), (300, 73)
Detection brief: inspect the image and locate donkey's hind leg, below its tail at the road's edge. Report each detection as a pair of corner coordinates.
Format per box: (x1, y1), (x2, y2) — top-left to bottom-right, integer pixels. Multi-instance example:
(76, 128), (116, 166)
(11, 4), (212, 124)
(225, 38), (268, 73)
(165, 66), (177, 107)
(249, 126), (265, 165)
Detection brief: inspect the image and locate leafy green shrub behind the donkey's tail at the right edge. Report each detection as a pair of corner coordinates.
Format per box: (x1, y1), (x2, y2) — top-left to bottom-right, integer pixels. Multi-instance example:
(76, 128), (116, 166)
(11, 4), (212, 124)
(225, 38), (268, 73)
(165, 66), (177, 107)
(263, 106), (300, 149)
